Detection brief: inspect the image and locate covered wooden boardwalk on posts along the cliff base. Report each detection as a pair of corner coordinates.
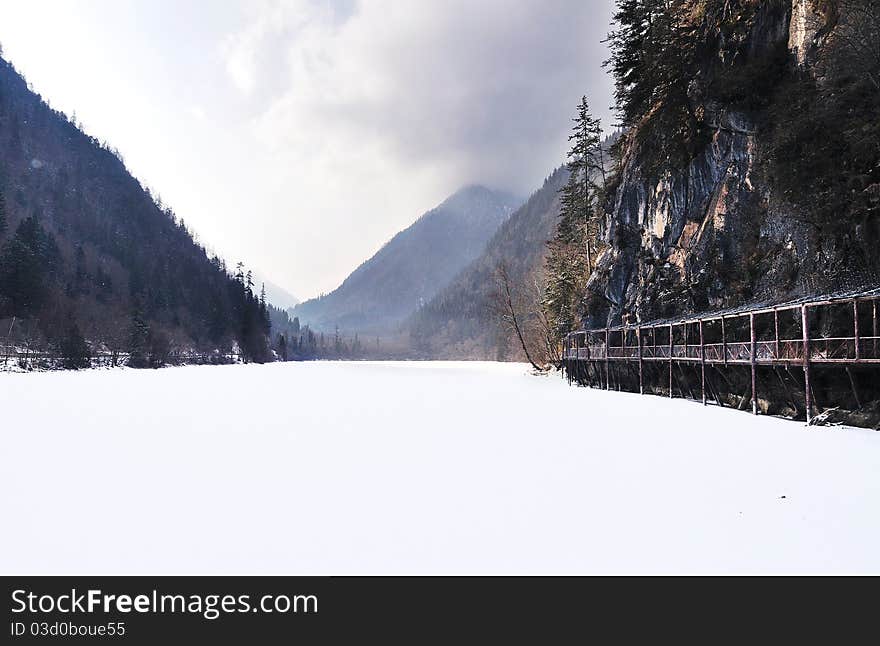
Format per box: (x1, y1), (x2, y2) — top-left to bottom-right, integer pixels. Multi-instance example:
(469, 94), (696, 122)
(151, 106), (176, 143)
(563, 288), (880, 422)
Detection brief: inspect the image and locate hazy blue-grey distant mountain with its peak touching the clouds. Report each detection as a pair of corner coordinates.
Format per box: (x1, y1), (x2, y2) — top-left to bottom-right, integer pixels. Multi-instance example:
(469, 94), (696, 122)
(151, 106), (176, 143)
(291, 186), (520, 334)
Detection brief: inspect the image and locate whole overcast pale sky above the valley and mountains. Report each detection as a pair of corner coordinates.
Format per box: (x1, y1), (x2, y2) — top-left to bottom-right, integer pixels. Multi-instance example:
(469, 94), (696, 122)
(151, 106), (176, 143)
(0, 0), (611, 298)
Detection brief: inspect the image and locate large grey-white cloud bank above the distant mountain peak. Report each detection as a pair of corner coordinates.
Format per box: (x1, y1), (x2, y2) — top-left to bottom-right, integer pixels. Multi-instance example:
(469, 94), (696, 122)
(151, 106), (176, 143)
(226, 0), (610, 192)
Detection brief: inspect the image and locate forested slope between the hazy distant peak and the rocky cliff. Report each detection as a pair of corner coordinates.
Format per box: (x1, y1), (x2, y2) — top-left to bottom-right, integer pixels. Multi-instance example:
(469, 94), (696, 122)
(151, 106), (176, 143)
(405, 168), (568, 360)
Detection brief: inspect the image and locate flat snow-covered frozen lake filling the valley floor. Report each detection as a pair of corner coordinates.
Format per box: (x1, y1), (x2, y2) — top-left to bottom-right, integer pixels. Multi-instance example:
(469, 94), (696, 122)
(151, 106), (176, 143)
(0, 363), (880, 574)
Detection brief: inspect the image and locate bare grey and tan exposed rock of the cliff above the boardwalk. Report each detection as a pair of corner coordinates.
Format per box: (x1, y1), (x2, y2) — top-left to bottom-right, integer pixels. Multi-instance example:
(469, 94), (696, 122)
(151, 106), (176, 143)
(585, 0), (863, 326)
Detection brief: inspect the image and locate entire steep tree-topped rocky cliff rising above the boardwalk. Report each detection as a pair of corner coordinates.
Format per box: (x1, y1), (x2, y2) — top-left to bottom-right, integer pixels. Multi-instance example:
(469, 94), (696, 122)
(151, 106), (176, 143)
(584, 0), (880, 327)
